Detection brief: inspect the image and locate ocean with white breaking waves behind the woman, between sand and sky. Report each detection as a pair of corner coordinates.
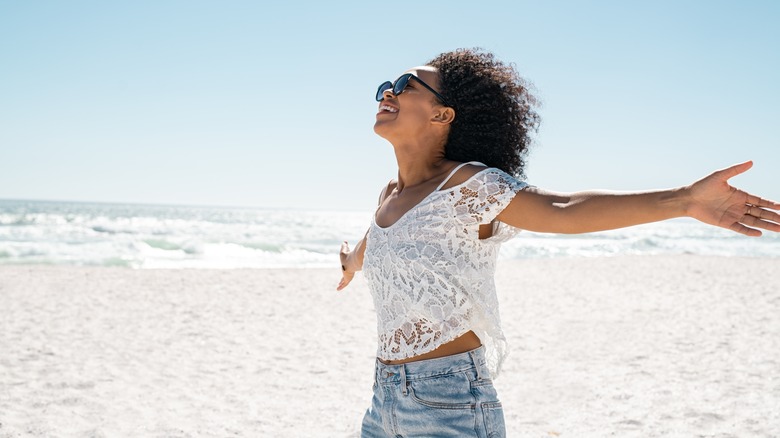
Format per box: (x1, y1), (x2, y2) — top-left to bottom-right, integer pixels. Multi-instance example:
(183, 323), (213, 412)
(0, 200), (780, 269)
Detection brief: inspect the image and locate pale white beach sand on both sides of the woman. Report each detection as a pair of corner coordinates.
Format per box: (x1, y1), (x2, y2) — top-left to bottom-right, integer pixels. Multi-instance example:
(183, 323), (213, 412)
(0, 256), (780, 437)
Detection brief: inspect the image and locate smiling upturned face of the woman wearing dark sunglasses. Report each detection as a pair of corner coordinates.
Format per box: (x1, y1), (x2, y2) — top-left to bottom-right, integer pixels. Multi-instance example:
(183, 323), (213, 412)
(374, 66), (452, 143)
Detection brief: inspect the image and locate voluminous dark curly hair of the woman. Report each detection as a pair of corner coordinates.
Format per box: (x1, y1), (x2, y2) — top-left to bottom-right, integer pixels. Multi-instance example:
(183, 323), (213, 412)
(427, 48), (540, 178)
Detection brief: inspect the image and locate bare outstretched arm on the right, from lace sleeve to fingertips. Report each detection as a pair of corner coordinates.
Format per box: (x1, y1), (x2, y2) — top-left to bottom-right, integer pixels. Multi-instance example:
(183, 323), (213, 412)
(498, 161), (780, 236)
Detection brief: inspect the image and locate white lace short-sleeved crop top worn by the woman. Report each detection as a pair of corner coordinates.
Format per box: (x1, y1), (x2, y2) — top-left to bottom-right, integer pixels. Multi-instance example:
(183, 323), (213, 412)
(363, 163), (527, 375)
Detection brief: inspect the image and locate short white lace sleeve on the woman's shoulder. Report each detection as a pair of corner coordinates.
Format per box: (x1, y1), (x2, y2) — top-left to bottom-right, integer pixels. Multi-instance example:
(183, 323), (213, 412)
(453, 168), (528, 226)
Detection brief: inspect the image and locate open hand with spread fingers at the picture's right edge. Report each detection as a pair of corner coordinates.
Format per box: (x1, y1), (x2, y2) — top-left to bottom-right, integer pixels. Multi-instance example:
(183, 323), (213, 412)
(686, 161), (780, 237)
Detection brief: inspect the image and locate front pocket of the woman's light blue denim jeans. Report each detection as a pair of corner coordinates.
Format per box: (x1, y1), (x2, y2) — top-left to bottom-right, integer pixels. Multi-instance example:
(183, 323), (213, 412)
(409, 373), (476, 409)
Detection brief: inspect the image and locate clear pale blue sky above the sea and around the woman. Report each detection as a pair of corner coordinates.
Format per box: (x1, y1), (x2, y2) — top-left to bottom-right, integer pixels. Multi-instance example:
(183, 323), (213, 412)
(0, 0), (780, 210)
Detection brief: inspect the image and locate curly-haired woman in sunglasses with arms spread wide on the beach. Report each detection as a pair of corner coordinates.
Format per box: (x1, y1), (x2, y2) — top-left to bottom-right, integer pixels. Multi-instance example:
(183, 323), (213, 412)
(338, 50), (780, 437)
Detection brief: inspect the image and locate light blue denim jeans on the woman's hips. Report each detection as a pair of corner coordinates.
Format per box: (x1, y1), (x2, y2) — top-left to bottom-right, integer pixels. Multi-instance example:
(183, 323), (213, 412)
(361, 347), (506, 438)
